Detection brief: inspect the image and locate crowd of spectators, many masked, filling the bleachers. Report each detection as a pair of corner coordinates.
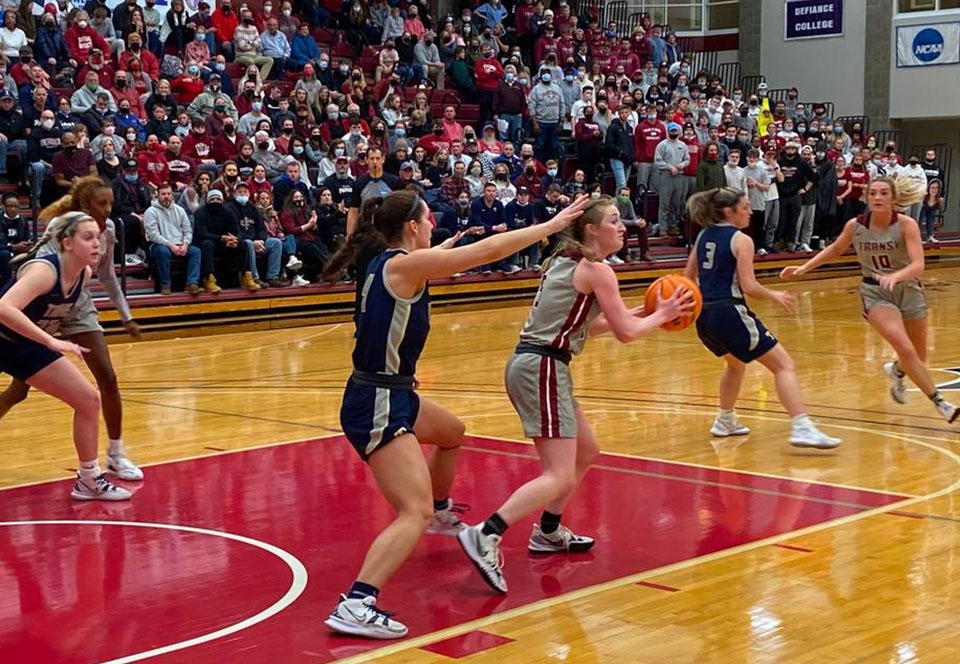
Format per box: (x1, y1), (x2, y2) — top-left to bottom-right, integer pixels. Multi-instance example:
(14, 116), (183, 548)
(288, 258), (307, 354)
(0, 0), (944, 293)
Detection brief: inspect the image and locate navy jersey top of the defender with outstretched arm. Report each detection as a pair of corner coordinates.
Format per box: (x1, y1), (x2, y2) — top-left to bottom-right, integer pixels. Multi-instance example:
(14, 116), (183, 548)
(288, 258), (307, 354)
(353, 249), (430, 376)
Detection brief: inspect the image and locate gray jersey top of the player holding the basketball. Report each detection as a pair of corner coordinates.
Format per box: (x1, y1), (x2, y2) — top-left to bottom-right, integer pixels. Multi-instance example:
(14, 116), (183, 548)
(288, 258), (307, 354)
(520, 256), (600, 355)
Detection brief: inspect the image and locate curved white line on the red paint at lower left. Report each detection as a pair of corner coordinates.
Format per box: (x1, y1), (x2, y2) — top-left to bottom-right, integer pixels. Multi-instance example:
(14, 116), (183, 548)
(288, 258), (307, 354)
(0, 520), (307, 664)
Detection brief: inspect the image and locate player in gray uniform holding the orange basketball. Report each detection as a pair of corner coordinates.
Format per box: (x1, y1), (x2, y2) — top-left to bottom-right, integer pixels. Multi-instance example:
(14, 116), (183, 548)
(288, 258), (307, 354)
(458, 196), (693, 593)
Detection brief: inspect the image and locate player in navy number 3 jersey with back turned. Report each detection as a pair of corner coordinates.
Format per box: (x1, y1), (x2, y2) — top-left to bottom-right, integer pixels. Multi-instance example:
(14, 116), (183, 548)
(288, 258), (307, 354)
(684, 187), (840, 449)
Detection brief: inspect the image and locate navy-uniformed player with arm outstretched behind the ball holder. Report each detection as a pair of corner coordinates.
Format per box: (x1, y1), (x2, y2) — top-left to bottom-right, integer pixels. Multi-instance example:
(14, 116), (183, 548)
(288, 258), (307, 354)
(324, 189), (587, 639)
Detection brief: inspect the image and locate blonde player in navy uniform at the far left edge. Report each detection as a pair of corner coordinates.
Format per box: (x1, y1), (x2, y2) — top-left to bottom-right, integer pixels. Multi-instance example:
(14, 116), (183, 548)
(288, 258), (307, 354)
(0, 212), (130, 500)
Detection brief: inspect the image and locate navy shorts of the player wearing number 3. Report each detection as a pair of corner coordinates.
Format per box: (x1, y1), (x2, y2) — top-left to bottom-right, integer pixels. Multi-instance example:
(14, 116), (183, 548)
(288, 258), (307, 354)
(697, 304), (777, 362)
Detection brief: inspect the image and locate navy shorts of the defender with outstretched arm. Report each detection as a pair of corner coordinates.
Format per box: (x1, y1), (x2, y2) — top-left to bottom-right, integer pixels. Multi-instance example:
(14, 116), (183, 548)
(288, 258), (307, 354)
(340, 378), (420, 461)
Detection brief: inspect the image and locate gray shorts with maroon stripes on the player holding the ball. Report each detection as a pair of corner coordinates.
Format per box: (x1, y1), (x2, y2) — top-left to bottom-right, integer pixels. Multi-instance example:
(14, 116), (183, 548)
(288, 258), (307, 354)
(504, 353), (577, 438)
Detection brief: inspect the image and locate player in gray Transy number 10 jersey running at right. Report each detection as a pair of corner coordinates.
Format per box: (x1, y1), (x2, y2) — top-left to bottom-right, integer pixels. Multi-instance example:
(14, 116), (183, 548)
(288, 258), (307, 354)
(780, 177), (960, 423)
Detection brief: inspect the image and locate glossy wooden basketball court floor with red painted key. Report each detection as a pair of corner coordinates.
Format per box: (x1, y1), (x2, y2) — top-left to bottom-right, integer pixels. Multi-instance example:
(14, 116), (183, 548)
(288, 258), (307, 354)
(0, 268), (960, 664)
